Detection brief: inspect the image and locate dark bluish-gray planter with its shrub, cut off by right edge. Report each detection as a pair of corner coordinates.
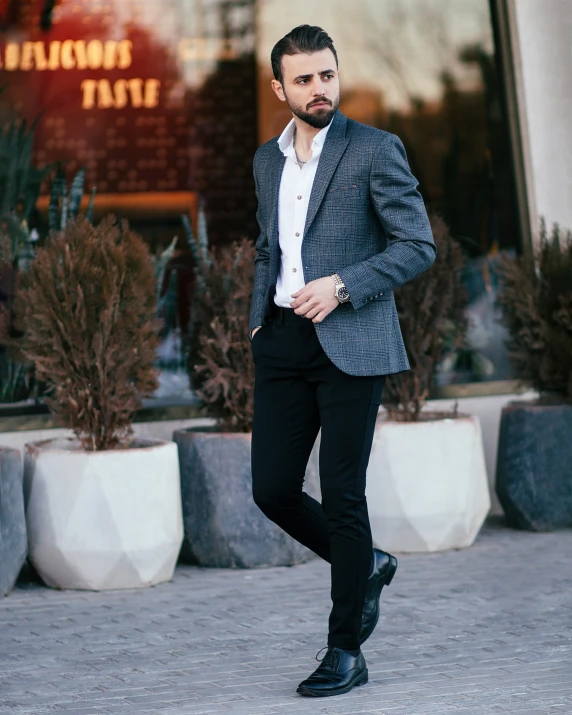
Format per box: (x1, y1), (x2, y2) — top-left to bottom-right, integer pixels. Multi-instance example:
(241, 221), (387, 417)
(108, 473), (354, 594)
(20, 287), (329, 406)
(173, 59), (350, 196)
(495, 221), (572, 531)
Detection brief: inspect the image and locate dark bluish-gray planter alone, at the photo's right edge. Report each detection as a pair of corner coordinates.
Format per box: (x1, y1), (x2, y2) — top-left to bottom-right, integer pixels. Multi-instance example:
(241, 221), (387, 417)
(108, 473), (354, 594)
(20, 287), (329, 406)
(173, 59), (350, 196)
(496, 403), (572, 531)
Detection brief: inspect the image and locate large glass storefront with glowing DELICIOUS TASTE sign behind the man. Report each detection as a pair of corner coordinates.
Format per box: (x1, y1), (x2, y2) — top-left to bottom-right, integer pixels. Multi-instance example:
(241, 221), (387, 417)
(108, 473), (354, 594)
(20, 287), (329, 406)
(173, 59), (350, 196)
(0, 0), (518, 408)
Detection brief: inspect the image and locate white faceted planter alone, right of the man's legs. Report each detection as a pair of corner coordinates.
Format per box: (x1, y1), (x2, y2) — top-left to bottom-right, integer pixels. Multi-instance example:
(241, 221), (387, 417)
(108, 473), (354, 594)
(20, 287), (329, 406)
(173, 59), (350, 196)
(366, 417), (490, 552)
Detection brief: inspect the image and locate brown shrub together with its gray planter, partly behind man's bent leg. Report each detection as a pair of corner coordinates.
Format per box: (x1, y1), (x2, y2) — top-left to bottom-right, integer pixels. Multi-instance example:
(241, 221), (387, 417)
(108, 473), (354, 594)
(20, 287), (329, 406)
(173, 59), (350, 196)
(173, 224), (317, 568)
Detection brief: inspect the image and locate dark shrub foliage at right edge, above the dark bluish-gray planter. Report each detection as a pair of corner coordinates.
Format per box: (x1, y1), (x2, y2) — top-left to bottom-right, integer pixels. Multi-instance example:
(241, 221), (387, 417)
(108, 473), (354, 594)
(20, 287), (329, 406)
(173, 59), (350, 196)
(498, 220), (572, 401)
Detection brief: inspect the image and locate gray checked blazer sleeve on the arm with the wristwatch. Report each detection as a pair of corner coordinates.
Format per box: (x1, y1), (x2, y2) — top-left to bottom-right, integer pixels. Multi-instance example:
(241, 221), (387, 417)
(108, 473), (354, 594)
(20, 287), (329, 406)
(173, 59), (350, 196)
(338, 134), (436, 310)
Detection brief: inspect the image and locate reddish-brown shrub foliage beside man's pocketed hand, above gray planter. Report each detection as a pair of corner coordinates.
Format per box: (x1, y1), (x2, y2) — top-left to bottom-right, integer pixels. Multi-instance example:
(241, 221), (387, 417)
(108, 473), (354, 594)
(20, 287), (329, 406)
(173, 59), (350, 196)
(191, 239), (255, 432)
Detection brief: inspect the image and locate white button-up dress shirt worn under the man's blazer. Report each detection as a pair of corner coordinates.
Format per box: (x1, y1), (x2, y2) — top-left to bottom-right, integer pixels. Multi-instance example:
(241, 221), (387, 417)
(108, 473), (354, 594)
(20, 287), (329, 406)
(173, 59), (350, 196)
(274, 119), (331, 308)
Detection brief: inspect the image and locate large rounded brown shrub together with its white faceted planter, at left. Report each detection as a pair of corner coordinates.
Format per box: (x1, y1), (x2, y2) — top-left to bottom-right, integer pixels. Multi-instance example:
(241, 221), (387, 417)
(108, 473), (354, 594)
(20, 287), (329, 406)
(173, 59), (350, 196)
(16, 216), (182, 590)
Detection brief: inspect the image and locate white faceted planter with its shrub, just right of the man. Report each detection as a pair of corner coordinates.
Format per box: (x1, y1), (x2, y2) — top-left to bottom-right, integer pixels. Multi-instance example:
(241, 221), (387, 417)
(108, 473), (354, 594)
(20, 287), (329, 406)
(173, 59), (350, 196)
(366, 214), (490, 552)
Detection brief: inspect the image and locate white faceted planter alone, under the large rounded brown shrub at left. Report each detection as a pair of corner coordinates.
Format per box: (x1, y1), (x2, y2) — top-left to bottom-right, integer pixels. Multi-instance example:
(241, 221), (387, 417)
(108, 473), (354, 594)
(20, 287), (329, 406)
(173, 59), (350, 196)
(24, 439), (183, 591)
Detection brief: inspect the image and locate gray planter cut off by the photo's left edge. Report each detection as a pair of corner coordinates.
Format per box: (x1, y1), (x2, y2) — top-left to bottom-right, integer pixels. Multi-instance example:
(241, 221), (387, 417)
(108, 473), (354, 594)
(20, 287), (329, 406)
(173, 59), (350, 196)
(0, 447), (28, 596)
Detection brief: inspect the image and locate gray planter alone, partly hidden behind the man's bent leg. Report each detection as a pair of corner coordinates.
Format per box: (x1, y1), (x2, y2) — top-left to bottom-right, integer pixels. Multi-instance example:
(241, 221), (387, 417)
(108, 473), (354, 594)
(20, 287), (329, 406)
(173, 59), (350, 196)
(173, 428), (318, 568)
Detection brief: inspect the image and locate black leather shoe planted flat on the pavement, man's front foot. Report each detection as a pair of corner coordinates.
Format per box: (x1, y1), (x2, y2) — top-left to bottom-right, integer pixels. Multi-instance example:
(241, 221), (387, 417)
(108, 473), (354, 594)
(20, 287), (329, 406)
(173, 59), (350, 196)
(296, 648), (367, 698)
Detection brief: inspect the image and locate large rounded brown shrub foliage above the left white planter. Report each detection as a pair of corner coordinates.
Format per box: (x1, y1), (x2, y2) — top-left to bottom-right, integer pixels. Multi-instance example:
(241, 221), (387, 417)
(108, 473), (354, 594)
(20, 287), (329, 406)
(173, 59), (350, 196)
(16, 216), (158, 450)
